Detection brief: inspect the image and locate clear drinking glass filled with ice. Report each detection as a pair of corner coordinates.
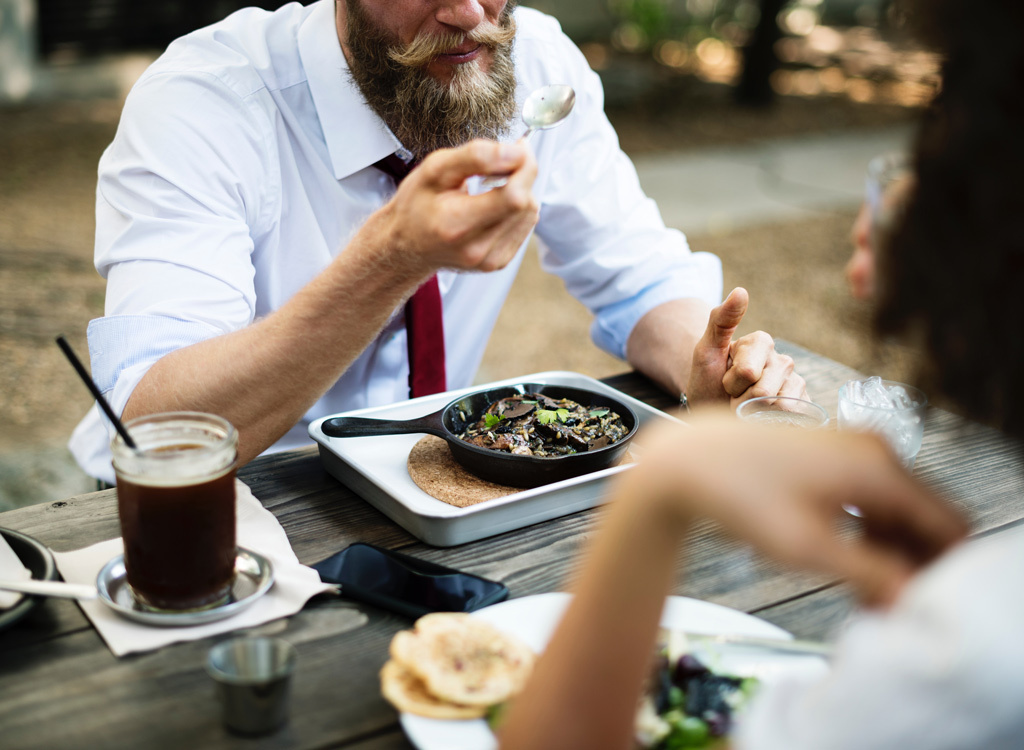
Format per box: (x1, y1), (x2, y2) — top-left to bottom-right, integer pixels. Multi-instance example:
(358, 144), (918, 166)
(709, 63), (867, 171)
(839, 376), (928, 469)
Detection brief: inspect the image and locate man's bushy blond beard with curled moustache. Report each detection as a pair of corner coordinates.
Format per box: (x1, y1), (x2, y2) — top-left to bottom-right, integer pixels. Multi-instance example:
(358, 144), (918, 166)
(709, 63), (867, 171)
(345, 0), (516, 159)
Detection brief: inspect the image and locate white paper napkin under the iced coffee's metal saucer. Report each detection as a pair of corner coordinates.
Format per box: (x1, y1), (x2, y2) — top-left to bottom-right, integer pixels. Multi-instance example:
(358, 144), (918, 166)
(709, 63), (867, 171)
(53, 482), (331, 657)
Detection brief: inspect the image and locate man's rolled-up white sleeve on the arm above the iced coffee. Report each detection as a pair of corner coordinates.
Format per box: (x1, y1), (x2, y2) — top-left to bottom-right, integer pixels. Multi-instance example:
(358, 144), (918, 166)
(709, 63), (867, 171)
(88, 68), (272, 403)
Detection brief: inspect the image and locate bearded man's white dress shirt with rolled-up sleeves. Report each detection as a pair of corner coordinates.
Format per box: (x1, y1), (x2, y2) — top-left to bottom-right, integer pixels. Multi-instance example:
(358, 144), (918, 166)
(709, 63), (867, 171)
(71, 0), (722, 481)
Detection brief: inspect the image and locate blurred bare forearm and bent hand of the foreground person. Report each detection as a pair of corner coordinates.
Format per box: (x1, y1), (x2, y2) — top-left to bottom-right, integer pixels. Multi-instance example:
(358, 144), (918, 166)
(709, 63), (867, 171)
(501, 415), (964, 750)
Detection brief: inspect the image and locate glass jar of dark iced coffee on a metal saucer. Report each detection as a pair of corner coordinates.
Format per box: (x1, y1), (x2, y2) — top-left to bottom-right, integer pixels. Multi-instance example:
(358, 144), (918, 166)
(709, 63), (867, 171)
(111, 412), (239, 612)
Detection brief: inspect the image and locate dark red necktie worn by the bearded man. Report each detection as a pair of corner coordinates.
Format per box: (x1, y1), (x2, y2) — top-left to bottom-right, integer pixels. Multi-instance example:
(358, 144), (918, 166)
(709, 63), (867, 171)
(374, 154), (447, 399)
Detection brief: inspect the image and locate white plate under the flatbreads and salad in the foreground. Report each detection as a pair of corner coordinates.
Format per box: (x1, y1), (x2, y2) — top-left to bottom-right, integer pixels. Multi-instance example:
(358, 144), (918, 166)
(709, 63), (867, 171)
(400, 593), (827, 750)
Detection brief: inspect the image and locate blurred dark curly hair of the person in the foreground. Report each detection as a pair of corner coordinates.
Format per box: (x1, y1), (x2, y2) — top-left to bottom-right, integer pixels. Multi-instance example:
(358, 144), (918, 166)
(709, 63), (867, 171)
(876, 0), (1024, 436)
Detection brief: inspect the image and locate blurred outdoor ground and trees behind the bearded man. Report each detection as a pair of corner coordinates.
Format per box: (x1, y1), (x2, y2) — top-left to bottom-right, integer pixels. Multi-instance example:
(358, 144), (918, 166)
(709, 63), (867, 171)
(0, 0), (939, 509)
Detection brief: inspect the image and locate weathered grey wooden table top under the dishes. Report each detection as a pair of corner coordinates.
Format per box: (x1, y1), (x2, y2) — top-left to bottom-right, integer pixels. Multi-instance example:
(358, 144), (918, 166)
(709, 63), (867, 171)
(0, 342), (1024, 750)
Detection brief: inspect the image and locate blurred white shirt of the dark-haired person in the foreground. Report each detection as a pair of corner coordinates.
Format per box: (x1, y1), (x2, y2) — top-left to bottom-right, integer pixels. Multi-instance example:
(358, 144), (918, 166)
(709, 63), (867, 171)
(734, 530), (1024, 750)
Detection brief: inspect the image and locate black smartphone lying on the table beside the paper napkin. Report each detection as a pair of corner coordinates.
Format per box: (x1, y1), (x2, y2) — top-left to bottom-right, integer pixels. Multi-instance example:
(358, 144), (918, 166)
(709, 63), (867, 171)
(311, 542), (509, 618)
